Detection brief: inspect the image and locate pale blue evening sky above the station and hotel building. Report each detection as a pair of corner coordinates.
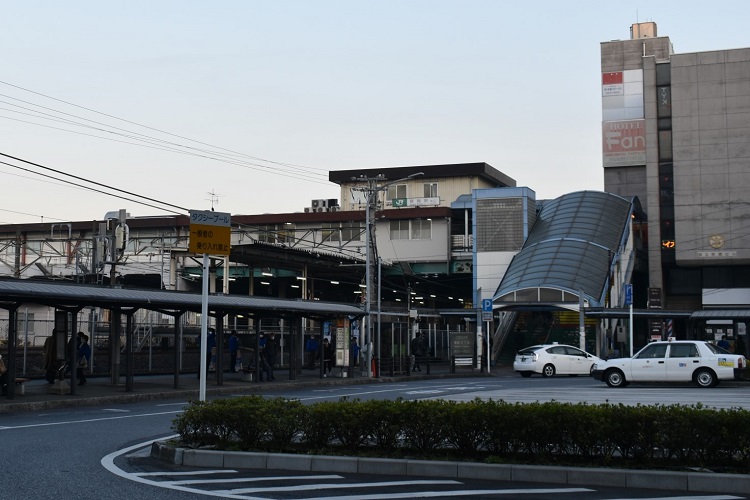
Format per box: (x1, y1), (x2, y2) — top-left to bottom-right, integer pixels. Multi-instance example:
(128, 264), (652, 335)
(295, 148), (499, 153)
(0, 0), (750, 224)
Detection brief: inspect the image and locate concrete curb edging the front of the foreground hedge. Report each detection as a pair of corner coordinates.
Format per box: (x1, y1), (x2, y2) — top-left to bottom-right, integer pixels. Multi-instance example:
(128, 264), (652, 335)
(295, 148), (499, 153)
(151, 441), (750, 495)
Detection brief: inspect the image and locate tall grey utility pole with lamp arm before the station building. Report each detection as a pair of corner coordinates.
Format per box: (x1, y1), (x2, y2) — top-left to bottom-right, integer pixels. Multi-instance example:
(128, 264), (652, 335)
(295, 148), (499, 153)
(352, 172), (424, 378)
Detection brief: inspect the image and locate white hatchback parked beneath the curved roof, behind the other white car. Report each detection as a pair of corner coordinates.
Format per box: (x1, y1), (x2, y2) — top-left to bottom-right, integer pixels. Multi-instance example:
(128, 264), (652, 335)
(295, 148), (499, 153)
(513, 344), (602, 377)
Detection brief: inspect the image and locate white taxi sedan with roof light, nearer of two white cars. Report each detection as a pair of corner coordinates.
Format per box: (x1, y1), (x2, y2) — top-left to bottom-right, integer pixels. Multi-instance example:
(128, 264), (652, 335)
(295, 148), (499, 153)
(592, 340), (747, 387)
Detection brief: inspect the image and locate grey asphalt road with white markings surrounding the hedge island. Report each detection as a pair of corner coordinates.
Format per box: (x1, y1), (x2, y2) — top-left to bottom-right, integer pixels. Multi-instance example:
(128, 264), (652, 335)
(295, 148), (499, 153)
(0, 375), (750, 500)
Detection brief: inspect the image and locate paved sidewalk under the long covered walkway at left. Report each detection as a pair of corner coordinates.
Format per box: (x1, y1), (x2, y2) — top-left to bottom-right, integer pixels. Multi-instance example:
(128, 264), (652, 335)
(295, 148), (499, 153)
(0, 364), (481, 414)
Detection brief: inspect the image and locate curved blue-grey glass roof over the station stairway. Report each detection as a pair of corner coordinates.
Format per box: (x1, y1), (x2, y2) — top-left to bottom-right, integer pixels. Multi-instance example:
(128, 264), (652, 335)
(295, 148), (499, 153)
(494, 191), (633, 308)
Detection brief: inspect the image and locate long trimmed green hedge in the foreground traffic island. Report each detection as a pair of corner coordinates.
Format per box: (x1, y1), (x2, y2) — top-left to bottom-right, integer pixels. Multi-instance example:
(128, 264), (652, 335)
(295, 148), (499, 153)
(172, 396), (750, 472)
